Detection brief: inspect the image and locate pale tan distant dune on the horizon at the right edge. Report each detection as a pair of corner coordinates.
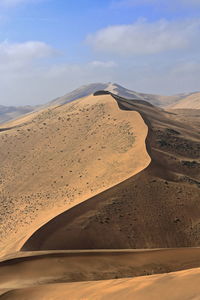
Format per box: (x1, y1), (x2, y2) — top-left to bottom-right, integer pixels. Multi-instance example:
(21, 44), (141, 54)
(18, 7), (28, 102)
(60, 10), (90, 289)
(168, 92), (200, 109)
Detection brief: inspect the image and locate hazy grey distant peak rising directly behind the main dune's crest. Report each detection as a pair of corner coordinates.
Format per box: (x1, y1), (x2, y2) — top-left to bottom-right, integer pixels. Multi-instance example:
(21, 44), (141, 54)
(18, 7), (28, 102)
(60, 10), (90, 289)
(48, 83), (190, 107)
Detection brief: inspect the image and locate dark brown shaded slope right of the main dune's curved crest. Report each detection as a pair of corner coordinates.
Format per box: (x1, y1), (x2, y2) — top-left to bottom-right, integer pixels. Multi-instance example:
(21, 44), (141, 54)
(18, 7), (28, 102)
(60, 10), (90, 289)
(22, 95), (200, 251)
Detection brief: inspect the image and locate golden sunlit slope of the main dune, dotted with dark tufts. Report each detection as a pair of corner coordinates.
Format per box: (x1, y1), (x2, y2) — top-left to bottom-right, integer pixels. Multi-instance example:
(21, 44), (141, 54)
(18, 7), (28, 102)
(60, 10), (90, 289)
(0, 95), (150, 254)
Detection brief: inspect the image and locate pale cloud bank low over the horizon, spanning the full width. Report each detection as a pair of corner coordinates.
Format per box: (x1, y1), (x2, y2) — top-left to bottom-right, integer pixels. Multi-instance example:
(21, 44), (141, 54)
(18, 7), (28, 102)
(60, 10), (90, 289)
(0, 38), (200, 105)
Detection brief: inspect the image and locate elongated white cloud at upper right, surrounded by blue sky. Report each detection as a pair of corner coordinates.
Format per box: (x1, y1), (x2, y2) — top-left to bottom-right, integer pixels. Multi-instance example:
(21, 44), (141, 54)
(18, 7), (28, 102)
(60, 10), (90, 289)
(87, 20), (200, 55)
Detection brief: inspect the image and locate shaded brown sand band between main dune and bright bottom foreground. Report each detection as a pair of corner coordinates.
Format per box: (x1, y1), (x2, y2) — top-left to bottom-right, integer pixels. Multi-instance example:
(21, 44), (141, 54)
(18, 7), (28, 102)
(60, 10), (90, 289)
(0, 248), (200, 299)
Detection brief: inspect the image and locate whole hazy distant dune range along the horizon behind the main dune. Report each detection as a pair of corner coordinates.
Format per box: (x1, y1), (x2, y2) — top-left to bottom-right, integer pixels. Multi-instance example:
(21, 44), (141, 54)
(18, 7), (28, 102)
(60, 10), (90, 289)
(0, 82), (200, 124)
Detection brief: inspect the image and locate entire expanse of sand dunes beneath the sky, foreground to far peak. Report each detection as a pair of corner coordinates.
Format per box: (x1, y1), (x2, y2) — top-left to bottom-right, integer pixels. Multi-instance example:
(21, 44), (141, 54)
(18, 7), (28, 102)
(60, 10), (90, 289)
(0, 83), (200, 300)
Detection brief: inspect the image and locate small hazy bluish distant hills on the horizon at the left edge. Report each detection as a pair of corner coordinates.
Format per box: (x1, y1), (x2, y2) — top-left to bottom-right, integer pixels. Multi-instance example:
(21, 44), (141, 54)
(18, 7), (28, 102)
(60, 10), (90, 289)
(0, 105), (35, 124)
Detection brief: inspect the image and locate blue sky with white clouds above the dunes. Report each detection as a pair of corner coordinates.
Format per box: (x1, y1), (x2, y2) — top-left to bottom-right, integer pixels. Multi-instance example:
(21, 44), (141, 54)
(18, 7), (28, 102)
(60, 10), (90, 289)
(0, 0), (200, 105)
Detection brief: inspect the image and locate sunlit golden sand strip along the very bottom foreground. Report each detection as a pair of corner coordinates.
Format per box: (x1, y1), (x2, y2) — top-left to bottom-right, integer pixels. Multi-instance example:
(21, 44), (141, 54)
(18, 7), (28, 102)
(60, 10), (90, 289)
(0, 268), (200, 300)
